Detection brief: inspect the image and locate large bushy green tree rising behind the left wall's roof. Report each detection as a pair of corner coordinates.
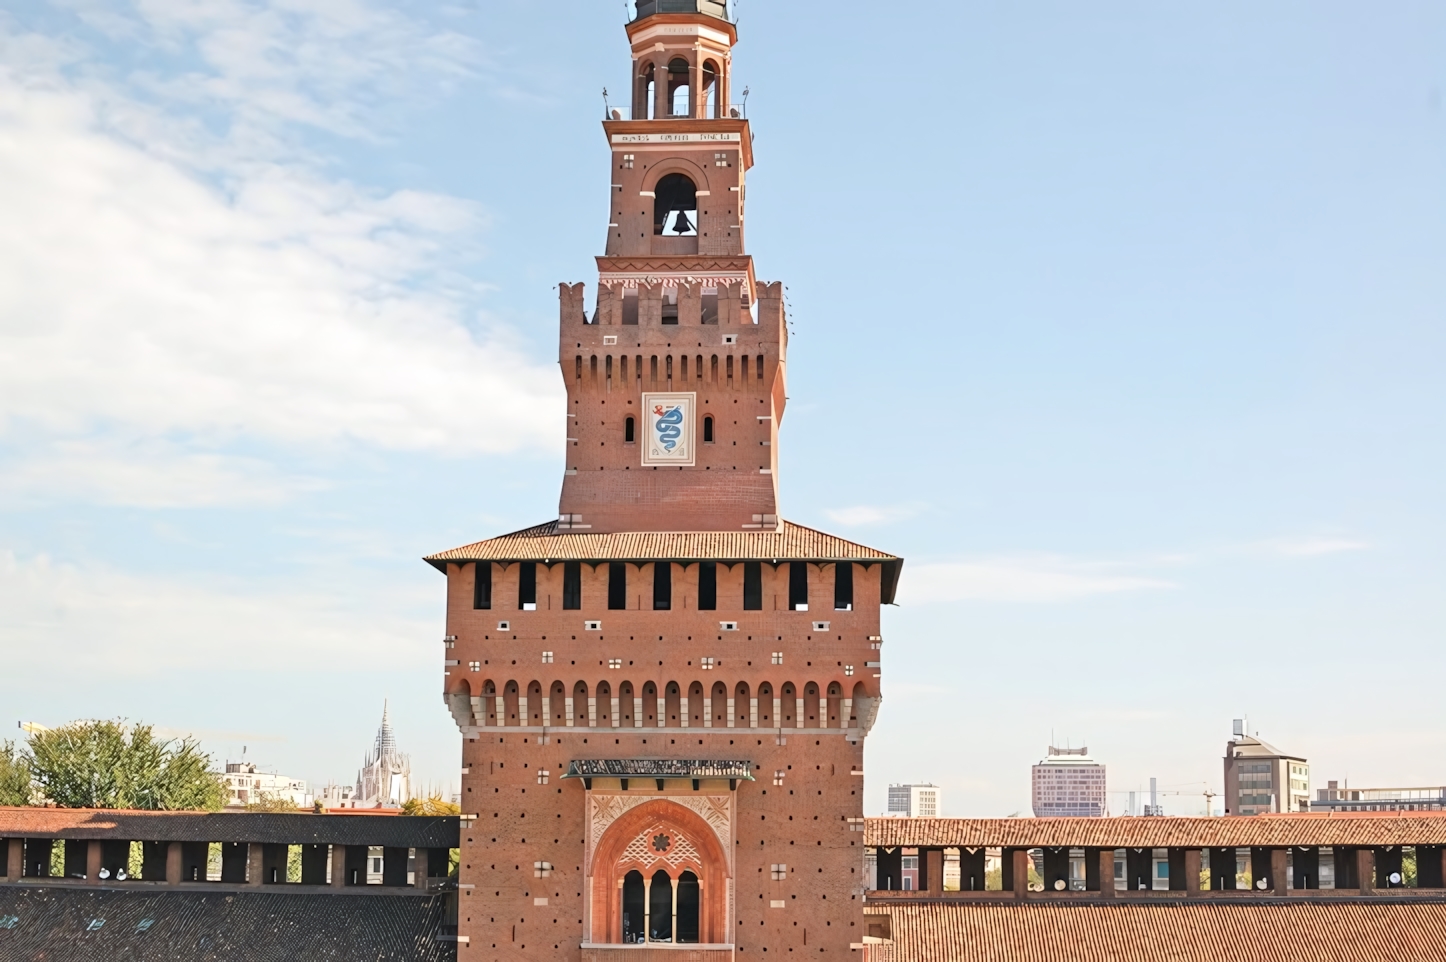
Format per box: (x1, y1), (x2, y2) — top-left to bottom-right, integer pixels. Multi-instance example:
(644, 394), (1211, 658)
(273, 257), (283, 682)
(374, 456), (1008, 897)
(25, 722), (226, 812)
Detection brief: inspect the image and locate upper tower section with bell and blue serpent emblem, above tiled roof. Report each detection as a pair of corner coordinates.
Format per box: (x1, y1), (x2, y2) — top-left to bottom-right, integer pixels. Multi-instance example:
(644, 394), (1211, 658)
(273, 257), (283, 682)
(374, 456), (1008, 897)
(558, 0), (787, 532)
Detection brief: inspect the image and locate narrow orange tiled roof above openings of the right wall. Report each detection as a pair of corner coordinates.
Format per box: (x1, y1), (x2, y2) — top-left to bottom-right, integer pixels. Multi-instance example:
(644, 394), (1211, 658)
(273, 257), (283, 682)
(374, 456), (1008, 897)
(863, 812), (1446, 848)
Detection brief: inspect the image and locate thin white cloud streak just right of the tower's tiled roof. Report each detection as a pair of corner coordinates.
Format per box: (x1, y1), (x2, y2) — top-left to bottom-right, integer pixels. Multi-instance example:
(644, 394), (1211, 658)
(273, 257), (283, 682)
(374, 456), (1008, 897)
(899, 557), (1174, 605)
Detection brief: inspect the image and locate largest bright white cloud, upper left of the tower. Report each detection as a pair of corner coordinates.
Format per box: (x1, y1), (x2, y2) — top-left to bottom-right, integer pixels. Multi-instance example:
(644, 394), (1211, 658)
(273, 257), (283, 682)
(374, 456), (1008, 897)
(0, 0), (562, 503)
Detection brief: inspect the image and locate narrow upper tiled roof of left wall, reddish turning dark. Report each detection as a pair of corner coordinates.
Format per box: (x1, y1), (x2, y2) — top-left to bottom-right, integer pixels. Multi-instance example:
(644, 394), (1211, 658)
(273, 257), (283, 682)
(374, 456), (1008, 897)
(0, 807), (461, 848)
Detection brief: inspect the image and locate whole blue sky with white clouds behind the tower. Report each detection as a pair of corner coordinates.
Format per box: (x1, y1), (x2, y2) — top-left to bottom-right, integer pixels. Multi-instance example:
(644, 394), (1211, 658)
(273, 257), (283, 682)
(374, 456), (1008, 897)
(0, 0), (1446, 814)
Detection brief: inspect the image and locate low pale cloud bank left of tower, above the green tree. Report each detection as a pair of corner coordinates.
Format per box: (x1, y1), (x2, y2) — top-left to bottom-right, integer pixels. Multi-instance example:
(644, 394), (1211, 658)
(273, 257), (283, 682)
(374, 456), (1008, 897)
(0, 543), (435, 678)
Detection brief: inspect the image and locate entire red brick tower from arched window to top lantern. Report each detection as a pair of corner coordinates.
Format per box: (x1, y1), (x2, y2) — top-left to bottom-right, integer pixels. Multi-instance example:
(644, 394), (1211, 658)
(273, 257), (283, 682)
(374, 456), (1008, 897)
(427, 0), (902, 962)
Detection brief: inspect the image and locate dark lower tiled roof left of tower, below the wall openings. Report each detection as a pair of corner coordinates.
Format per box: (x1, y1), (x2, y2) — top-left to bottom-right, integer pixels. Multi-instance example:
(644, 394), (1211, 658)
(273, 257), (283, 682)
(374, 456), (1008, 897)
(0, 884), (457, 962)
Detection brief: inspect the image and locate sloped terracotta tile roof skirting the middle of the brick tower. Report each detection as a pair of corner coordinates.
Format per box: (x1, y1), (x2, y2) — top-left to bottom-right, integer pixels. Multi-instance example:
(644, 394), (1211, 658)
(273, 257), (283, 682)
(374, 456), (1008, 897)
(425, 521), (899, 567)
